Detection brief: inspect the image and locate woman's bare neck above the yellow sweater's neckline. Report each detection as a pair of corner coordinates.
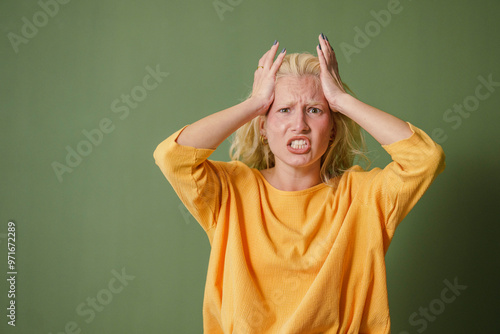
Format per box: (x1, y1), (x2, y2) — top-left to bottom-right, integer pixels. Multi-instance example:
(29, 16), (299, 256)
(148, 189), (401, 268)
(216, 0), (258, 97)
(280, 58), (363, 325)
(261, 162), (322, 191)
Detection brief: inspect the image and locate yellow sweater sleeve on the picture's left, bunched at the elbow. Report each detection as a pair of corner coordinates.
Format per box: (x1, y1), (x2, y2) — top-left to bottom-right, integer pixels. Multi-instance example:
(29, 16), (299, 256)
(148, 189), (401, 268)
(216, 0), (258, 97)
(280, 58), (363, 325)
(154, 126), (225, 232)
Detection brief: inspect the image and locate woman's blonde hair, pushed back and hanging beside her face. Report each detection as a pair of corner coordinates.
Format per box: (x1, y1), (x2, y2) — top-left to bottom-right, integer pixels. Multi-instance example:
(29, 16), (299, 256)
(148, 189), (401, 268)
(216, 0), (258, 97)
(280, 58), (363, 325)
(229, 53), (368, 185)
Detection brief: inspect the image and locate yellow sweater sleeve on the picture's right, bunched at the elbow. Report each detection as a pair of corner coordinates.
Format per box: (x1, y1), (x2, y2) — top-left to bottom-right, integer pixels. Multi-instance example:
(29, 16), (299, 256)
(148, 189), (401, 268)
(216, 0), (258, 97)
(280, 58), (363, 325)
(357, 123), (445, 230)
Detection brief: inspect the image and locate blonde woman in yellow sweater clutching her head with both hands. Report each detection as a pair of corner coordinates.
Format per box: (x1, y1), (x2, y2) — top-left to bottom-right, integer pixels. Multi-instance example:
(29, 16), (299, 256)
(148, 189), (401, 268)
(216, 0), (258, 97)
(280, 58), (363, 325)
(154, 34), (444, 333)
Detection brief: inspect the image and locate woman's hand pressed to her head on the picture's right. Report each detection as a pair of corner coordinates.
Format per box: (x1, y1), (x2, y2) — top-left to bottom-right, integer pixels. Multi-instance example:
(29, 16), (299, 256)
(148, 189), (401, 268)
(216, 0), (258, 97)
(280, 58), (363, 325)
(316, 34), (347, 112)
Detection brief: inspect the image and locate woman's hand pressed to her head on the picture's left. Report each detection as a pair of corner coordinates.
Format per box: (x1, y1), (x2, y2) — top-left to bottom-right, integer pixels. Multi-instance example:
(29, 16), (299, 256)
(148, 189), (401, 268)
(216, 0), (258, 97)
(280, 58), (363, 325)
(250, 41), (286, 115)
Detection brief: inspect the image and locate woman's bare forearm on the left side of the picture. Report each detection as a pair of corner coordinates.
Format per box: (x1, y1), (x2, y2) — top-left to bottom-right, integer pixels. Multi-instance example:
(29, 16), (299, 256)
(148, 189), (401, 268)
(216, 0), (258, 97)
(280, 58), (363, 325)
(177, 98), (263, 149)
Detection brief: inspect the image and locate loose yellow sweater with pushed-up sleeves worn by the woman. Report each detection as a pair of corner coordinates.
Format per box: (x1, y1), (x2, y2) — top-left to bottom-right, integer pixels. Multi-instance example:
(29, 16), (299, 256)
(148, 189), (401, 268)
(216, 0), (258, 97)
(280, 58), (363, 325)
(154, 124), (445, 334)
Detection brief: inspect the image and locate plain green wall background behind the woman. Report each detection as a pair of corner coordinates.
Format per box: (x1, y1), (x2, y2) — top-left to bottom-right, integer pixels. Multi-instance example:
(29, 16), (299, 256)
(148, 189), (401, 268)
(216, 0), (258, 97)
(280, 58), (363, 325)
(0, 0), (500, 334)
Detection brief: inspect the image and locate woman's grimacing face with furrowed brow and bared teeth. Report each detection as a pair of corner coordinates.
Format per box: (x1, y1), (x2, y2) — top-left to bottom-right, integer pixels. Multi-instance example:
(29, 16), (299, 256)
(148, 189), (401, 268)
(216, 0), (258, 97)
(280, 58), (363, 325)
(260, 75), (333, 171)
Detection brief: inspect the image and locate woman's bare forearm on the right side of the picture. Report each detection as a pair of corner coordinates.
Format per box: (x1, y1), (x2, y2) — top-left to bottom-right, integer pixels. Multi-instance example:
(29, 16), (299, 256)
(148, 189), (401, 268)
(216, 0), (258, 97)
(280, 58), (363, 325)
(334, 94), (412, 145)
